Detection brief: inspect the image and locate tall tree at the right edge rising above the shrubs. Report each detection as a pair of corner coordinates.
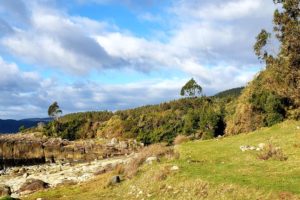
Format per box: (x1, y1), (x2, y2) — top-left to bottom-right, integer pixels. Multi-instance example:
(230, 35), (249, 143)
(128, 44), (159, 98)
(254, 0), (300, 106)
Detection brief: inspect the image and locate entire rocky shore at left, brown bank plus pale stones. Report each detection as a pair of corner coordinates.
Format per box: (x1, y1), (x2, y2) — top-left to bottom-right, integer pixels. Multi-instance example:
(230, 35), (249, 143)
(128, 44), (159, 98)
(0, 134), (143, 197)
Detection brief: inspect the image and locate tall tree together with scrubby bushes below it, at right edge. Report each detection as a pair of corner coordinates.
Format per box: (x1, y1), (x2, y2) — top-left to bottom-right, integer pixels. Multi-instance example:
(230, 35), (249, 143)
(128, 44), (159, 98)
(226, 0), (300, 135)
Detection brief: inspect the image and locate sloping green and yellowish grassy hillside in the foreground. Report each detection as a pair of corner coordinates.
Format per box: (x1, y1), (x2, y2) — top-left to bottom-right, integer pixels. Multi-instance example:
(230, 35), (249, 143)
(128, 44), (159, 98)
(25, 121), (300, 200)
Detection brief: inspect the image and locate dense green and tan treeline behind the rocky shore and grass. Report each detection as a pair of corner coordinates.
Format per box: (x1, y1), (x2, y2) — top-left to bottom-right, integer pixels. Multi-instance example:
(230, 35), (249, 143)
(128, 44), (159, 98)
(39, 92), (236, 144)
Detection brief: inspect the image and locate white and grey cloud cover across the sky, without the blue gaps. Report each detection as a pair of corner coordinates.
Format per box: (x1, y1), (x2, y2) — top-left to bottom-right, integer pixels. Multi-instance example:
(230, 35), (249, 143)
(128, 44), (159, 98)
(0, 0), (273, 118)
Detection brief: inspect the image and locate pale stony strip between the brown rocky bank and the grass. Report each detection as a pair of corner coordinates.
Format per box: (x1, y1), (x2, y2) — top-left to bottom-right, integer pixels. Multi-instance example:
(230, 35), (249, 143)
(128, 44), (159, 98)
(0, 153), (135, 198)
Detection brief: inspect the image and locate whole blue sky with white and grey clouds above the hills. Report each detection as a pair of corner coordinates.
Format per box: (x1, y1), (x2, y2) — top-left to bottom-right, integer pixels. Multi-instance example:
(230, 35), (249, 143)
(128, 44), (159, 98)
(0, 0), (275, 119)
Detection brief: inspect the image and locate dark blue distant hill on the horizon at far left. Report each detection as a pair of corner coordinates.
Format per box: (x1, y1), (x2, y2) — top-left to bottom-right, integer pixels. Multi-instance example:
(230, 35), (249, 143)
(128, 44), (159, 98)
(0, 118), (51, 134)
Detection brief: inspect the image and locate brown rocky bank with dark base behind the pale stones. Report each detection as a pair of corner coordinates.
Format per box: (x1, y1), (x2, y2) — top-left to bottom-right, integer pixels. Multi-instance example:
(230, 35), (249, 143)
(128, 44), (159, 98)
(0, 134), (143, 169)
